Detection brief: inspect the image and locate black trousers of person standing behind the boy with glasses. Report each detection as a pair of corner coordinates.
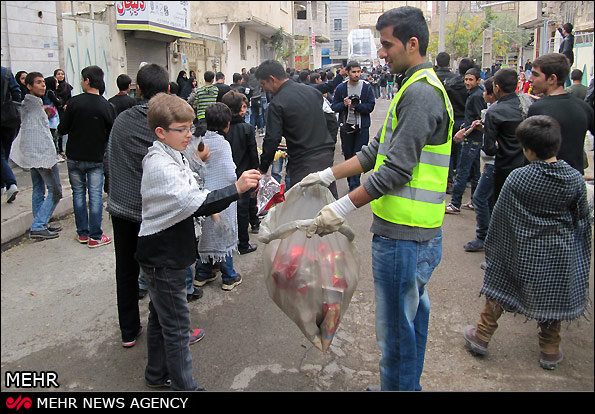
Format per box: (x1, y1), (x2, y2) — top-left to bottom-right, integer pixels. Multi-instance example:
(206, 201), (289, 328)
(111, 216), (141, 342)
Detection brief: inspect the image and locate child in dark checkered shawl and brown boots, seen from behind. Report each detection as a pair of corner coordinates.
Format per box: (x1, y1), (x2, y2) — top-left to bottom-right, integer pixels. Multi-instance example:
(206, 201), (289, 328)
(464, 115), (591, 369)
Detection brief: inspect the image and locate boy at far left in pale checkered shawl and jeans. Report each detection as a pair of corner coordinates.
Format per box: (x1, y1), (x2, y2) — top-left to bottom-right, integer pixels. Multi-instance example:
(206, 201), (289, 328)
(10, 72), (62, 239)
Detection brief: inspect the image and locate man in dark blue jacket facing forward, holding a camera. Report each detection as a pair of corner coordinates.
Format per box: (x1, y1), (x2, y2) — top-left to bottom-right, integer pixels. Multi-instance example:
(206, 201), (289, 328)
(331, 61), (376, 191)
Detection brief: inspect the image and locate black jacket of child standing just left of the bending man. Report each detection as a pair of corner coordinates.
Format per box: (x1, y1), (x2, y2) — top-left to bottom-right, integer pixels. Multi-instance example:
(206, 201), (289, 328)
(225, 115), (258, 178)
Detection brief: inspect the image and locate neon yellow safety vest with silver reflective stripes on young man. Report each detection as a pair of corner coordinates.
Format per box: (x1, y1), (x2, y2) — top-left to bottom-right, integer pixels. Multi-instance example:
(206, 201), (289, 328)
(370, 68), (454, 228)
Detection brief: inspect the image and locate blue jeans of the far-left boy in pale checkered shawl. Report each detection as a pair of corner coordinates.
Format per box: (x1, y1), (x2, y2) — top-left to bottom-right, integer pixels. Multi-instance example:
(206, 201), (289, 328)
(31, 164), (62, 231)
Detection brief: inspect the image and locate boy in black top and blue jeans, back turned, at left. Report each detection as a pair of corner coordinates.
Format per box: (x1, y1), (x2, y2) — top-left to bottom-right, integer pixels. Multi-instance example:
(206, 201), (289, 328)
(58, 66), (114, 248)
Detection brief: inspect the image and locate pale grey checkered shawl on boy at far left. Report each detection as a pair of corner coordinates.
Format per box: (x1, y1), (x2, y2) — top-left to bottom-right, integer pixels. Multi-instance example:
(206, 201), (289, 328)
(10, 94), (58, 168)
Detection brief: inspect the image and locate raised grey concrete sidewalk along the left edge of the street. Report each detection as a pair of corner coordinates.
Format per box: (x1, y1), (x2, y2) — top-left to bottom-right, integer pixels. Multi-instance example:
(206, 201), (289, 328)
(0, 160), (107, 244)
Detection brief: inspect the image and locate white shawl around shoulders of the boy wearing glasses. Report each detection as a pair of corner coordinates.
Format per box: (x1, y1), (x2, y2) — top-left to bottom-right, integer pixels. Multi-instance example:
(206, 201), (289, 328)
(138, 141), (209, 236)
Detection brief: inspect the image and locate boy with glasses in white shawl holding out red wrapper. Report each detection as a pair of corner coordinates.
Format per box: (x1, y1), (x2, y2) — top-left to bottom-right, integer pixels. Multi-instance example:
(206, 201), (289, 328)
(139, 93), (260, 391)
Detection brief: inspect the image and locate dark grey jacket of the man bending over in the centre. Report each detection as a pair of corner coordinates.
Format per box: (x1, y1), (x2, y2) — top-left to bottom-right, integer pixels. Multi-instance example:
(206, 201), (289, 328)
(259, 79), (335, 171)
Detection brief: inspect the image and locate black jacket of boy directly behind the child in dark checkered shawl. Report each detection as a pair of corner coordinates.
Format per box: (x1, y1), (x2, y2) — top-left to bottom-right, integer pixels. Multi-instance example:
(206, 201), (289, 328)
(483, 93), (527, 171)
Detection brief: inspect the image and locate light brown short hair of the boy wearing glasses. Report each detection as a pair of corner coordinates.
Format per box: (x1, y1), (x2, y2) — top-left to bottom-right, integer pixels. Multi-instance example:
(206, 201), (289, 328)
(147, 92), (195, 131)
